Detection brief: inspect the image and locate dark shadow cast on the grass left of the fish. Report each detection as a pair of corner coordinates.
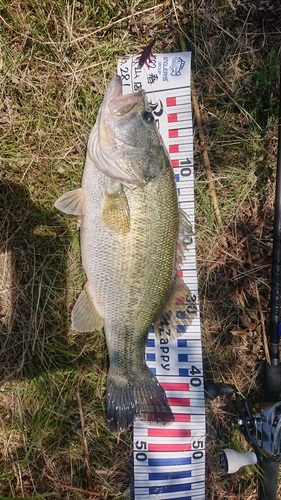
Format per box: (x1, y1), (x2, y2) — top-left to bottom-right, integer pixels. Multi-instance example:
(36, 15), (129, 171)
(0, 181), (73, 383)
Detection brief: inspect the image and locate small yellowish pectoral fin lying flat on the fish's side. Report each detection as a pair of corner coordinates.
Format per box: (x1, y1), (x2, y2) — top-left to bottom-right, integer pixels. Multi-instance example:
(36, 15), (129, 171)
(102, 182), (130, 235)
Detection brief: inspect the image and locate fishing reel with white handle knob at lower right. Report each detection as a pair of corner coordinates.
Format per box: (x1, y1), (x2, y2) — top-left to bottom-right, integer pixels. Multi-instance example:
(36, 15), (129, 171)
(205, 381), (281, 474)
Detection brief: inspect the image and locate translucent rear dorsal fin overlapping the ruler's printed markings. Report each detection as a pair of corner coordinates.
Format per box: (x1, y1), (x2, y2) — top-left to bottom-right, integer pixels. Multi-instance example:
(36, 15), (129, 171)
(153, 274), (198, 339)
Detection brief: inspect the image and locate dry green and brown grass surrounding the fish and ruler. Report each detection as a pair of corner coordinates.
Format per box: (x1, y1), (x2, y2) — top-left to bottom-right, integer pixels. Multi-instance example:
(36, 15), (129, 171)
(0, 0), (281, 500)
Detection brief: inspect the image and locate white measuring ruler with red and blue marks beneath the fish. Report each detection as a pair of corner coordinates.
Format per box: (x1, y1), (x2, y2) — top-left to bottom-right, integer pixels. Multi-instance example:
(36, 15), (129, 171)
(117, 52), (205, 500)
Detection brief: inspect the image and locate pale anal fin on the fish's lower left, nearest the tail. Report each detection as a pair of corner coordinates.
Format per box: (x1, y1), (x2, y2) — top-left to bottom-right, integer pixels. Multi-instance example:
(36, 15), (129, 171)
(72, 283), (103, 332)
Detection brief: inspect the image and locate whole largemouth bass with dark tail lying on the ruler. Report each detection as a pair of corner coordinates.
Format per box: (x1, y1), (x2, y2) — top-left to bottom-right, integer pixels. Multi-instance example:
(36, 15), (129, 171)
(55, 75), (197, 435)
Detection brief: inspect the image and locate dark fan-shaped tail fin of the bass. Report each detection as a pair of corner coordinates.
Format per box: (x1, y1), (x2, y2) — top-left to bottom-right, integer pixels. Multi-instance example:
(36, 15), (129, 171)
(106, 369), (174, 433)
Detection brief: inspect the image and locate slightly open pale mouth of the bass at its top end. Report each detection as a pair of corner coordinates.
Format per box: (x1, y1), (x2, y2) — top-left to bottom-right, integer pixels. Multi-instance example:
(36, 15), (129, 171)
(108, 75), (145, 117)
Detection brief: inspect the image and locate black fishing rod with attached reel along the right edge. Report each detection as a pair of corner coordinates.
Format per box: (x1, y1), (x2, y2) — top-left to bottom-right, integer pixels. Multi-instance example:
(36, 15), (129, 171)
(205, 67), (281, 500)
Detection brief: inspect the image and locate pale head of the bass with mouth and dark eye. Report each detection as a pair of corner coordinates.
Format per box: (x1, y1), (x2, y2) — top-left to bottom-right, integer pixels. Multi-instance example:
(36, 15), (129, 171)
(88, 76), (167, 186)
